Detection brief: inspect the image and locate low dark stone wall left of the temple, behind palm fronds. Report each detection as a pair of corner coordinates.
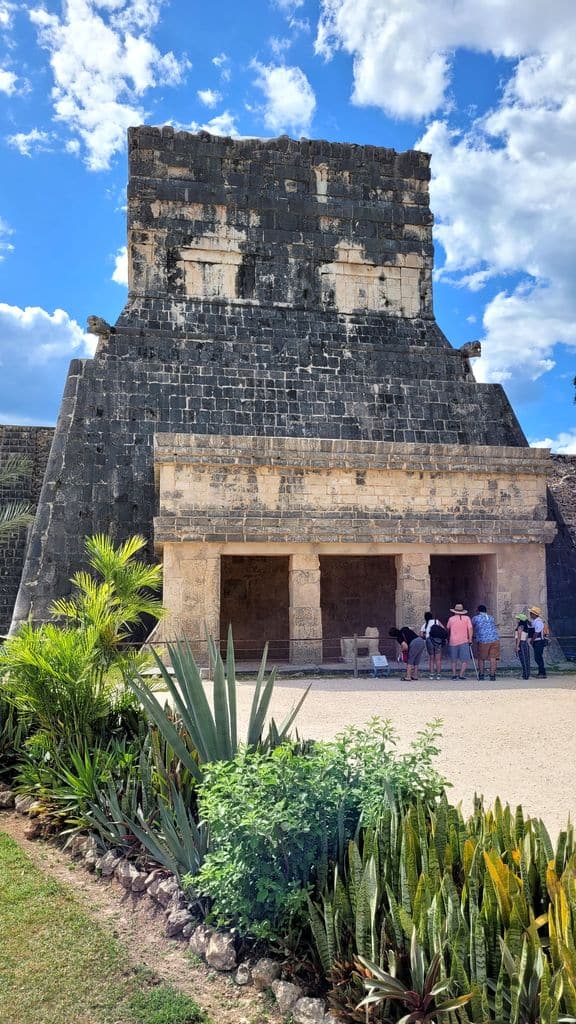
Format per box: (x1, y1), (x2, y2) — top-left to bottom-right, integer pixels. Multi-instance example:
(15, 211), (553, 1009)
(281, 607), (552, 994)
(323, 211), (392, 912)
(0, 424), (54, 635)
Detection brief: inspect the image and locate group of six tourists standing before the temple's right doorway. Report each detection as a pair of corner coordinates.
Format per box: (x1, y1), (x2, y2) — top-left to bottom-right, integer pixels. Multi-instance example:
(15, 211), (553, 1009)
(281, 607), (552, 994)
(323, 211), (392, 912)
(388, 603), (548, 682)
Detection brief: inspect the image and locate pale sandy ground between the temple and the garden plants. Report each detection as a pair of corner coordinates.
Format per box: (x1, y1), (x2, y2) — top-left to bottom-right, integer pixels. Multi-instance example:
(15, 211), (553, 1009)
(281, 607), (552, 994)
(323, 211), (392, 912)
(228, 675), (576, 839)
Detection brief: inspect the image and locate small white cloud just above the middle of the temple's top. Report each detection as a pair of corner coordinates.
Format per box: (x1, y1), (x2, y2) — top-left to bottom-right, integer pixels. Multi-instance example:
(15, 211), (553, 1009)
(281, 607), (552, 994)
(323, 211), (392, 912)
(252, 60), (316, 135)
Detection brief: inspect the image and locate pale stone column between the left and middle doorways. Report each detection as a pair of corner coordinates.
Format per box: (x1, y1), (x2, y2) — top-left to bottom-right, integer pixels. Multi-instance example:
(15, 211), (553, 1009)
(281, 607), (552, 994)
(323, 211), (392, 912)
(289, 554), (322, 665)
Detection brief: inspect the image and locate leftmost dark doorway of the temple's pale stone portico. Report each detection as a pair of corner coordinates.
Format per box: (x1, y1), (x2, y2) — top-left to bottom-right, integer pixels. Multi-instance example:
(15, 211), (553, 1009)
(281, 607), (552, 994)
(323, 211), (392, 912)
(220, 555), (290, 662)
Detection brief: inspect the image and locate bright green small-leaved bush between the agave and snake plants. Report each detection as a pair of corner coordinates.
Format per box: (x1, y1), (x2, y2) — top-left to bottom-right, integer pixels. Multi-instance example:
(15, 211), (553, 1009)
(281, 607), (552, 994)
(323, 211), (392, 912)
(195, 720), (443, 936)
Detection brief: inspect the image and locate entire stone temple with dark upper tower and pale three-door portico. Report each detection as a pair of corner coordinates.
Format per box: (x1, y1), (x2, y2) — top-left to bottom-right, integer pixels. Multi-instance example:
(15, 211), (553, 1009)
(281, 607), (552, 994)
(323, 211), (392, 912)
(8, 127), (557, 664)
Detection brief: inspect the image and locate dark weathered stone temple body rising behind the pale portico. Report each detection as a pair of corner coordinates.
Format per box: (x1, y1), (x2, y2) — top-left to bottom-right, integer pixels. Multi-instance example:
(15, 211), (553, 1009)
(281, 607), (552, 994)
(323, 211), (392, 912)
(4, 121), (569, 647)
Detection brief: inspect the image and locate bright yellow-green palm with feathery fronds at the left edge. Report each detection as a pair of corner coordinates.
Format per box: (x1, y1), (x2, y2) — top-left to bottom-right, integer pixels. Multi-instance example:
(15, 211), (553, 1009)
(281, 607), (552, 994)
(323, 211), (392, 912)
(0, 537), (162, 753)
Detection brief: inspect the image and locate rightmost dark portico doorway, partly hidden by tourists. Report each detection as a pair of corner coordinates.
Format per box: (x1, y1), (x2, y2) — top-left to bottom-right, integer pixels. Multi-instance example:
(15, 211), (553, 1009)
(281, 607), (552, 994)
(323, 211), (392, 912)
(430, 555), (496, 623)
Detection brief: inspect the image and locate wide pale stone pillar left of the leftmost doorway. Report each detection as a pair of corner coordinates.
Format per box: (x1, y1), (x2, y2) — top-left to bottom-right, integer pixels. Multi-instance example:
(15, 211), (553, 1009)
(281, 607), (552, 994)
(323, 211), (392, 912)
(159, 544), (220, 664)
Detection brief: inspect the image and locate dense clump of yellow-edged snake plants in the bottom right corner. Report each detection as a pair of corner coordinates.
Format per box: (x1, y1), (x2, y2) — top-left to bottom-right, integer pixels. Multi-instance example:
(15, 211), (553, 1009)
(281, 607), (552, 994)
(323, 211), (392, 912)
(310, 799), (576, 1024)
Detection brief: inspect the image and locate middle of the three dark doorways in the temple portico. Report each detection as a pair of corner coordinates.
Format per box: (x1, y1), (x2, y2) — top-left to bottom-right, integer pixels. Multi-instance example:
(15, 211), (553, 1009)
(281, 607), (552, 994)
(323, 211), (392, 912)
(320, 555), (396, 662)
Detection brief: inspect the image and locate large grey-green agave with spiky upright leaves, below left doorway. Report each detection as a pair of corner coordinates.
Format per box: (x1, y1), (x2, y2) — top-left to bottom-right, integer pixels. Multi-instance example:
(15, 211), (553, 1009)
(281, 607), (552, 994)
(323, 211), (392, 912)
(128, 630), (310, 781)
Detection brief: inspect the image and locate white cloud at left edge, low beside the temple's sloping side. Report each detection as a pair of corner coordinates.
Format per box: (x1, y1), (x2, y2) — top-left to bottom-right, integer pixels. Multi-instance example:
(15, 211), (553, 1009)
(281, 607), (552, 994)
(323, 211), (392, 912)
(0, 302), (96, 367)
